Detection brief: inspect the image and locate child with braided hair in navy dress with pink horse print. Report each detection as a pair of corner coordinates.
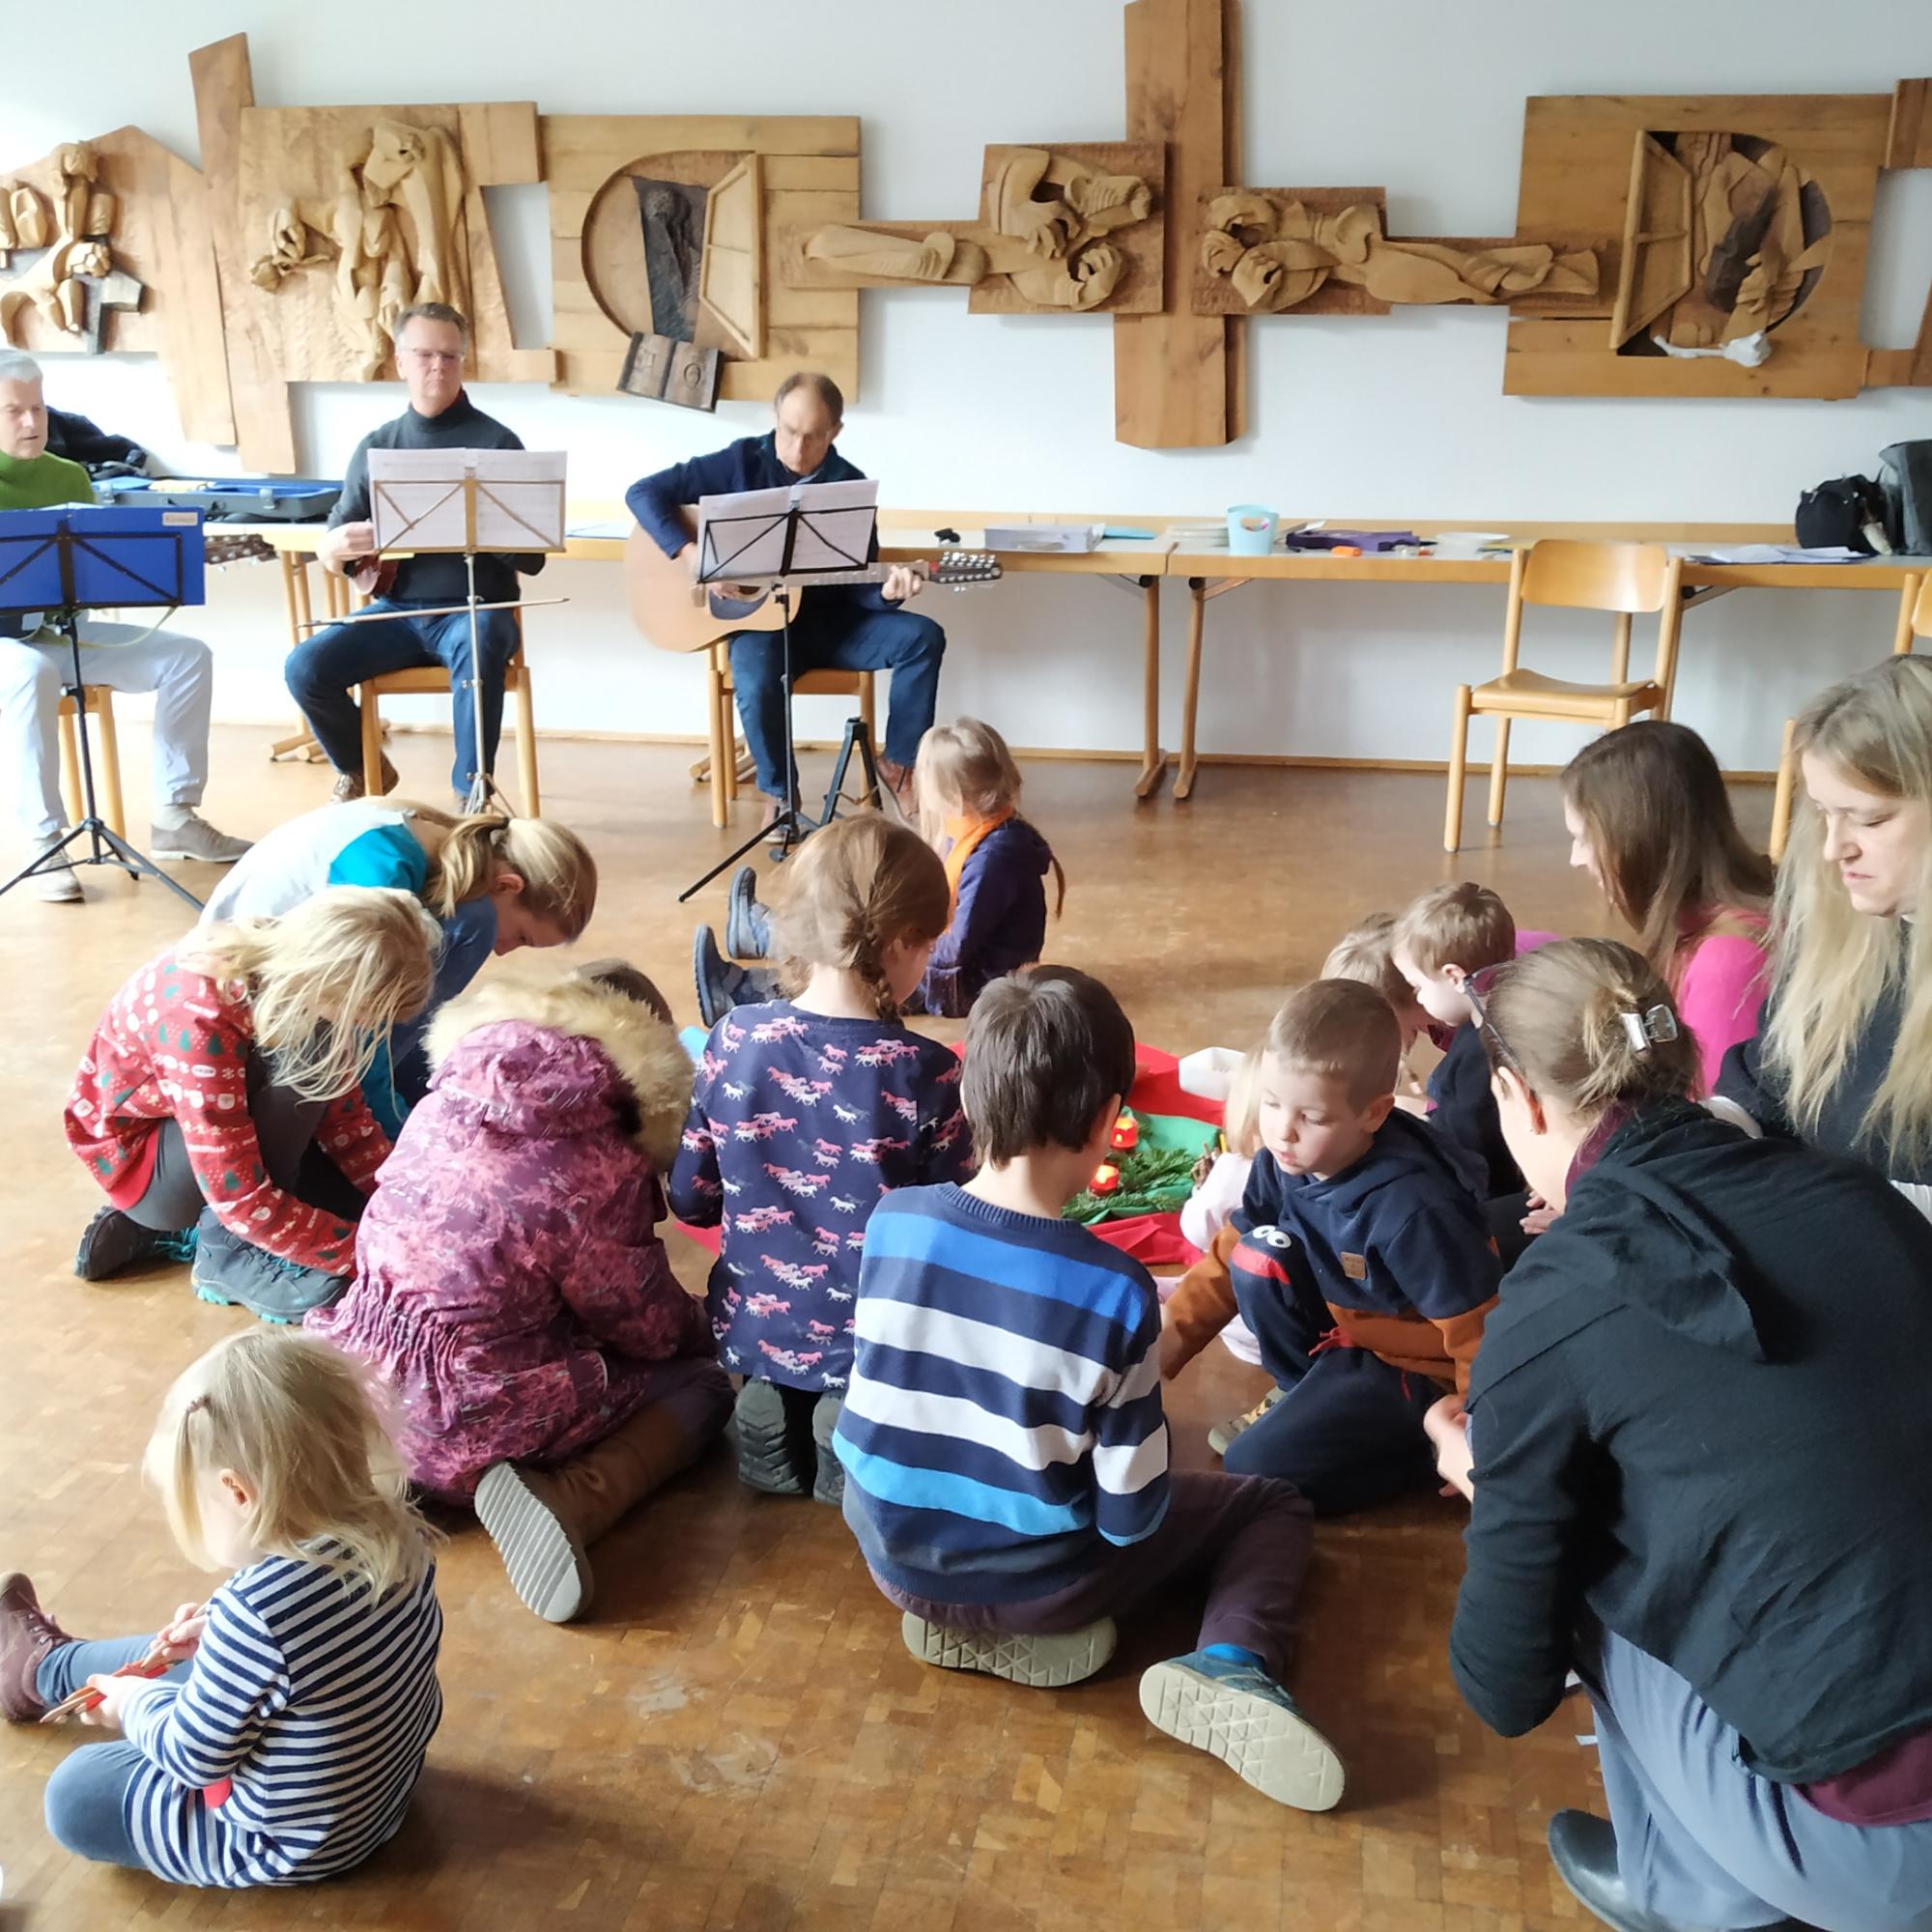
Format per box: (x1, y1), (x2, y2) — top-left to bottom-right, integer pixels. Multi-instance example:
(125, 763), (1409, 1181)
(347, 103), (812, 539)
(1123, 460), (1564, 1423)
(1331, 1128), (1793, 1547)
(670, 811), (972, 1505)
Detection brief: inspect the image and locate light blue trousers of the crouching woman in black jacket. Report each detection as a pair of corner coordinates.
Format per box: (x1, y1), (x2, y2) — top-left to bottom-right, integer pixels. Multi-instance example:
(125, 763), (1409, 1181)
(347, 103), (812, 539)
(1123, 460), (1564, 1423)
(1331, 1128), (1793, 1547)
(1577, 1631), (1932, 1932)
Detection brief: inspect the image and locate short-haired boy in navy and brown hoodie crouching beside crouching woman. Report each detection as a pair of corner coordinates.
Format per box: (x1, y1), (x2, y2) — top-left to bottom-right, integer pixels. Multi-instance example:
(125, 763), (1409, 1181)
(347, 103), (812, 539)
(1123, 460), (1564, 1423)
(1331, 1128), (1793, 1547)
(1161, 980), (1501, 1515)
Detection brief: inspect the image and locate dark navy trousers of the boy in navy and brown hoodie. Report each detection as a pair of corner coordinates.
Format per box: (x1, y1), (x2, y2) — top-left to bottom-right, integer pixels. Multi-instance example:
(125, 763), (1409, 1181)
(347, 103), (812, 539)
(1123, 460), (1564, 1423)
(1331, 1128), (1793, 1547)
(1221, 1248), (1443, 1517)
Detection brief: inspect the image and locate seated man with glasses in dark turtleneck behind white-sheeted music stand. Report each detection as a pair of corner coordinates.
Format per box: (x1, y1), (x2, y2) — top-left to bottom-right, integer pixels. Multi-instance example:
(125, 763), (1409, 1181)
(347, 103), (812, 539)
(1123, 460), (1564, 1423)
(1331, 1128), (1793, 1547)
(286, 301), (543, 810)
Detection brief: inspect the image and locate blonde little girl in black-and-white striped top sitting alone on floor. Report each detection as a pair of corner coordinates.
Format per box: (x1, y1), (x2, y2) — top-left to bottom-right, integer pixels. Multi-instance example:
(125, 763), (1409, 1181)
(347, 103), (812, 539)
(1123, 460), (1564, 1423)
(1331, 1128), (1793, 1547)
(0, 1329), (442, 1888)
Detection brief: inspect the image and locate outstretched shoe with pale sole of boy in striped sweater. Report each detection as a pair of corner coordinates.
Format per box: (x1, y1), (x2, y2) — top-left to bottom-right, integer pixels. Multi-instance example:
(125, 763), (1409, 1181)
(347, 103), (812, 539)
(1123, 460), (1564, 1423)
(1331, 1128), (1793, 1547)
(1140, 1650), (1343, 1810)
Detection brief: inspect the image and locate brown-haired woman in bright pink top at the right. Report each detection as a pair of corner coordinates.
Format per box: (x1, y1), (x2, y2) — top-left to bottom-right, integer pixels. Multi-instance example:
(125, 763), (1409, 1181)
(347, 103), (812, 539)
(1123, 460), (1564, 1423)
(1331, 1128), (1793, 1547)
(1563, 719), (1776, 1094)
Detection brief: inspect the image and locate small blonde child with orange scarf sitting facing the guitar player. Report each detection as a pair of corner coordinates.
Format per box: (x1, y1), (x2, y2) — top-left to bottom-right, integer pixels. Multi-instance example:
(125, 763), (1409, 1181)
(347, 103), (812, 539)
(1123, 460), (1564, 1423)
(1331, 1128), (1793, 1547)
(692, 719), (1066, 1026)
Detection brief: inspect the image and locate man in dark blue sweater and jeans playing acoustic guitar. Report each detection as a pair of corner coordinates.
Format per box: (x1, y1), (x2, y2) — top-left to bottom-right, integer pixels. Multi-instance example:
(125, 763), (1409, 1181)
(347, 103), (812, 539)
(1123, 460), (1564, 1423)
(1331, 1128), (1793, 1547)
(624, 371), (947, 815)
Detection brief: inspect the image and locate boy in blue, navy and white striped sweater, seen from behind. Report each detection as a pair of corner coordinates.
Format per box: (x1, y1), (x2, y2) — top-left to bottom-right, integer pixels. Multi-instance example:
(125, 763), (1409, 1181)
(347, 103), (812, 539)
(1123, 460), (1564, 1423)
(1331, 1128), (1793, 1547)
(835, 966), (1343, 1810)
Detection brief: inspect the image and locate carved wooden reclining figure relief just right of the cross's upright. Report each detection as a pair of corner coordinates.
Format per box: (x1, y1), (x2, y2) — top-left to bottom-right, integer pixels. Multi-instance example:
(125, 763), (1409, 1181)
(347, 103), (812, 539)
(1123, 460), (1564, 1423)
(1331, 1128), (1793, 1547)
(1194, 187), (1598, 315)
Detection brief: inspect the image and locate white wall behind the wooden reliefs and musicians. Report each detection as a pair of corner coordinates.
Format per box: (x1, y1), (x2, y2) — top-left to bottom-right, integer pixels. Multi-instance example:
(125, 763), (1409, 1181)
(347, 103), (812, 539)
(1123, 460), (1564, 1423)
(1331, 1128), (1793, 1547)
(0, 0), (1932, 767)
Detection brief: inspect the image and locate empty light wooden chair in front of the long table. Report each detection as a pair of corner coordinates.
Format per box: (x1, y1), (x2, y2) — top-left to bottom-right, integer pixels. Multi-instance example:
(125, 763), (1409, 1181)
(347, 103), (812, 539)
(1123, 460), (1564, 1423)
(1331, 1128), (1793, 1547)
(1443, 537), (1683, 852)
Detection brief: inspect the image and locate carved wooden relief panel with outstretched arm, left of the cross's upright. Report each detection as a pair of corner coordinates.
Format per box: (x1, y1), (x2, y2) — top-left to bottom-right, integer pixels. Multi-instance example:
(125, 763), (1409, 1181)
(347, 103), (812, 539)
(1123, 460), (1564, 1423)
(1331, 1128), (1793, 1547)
(784, 141), (1165, 315)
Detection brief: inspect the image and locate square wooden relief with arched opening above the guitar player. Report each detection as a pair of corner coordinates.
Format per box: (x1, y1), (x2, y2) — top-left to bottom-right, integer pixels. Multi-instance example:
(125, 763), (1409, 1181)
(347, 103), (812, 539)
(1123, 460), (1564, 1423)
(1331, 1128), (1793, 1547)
(539, 114), (858, 408)
